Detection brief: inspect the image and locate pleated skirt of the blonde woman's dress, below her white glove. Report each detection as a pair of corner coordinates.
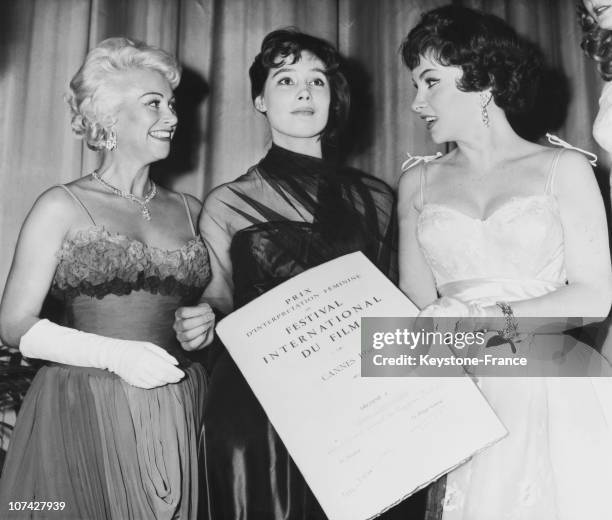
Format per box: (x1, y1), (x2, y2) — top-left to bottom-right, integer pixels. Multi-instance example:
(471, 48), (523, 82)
(0, 364), (207, 520)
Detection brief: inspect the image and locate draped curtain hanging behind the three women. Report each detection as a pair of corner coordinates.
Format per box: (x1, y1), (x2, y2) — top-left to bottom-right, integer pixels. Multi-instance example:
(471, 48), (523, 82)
(0, 0), (608, 291)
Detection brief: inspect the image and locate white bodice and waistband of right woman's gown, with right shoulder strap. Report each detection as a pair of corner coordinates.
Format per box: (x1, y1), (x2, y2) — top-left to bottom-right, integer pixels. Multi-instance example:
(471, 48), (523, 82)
(417, 152), (566, 303)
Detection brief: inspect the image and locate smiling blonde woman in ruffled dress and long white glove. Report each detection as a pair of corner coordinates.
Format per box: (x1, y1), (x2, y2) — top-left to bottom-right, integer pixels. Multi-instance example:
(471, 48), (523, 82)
(0, 38), (210, 520)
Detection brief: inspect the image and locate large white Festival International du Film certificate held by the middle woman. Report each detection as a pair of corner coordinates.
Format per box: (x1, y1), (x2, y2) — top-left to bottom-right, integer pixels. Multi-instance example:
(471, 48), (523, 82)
(216, 253), (507, 520)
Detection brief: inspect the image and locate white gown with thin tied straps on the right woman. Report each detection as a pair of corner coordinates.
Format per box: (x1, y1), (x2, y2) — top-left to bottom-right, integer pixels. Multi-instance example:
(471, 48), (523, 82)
(417, 151), (612, 520)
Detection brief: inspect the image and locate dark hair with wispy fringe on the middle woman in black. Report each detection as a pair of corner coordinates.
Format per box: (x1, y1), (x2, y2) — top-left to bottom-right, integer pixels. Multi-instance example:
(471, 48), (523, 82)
(249, 27), (351, 145)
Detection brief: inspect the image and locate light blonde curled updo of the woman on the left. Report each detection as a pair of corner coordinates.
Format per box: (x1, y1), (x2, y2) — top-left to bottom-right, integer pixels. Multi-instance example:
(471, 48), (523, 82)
(66, 38), (181, 151)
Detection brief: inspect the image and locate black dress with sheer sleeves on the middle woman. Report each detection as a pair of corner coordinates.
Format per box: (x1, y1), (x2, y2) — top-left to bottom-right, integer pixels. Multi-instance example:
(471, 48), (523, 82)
(201, 146), (421, 520)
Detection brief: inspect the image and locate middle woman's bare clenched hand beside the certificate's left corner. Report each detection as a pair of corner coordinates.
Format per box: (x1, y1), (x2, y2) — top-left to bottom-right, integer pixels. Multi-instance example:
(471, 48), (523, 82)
(173, 303), (215, 351)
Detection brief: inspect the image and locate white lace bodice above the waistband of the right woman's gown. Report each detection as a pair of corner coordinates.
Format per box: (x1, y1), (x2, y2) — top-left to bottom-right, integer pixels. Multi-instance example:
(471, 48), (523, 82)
(417, 195), (565, 286)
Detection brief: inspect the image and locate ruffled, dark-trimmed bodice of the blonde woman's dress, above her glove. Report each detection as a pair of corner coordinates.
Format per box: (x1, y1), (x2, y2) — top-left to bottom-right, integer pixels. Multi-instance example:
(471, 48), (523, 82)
(51, 226), (210, 358)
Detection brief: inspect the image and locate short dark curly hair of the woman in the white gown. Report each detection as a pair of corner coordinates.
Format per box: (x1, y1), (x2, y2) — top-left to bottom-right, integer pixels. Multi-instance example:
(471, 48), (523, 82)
(400, 5), (543, 114)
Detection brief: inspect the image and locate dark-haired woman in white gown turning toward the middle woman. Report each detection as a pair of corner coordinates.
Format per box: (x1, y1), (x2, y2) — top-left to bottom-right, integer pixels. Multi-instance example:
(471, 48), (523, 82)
(399, 6), (612, 520)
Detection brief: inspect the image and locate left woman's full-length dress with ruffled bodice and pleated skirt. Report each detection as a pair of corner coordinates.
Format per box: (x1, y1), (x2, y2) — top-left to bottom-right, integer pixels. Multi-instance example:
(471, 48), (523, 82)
(0, 188), (210, 520)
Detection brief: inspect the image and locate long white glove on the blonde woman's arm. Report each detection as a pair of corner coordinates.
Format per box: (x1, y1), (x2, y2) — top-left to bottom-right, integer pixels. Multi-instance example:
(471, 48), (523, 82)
(19, 320), (185, 388)
